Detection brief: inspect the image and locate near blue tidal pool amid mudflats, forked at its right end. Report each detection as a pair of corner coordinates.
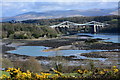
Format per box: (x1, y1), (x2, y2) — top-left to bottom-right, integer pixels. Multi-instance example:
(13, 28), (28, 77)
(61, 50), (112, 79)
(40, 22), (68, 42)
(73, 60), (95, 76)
(7, 46), (106, 60)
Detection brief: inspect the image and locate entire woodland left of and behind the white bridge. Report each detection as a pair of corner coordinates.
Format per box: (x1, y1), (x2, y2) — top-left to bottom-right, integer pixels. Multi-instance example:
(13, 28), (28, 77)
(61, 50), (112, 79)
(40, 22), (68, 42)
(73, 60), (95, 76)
(0, 15), (120, 39)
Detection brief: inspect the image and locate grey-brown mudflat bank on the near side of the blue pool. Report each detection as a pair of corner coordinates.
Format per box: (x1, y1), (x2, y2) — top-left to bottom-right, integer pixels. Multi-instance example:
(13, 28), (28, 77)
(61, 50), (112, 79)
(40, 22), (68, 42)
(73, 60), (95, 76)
(3, 51), (119, 69)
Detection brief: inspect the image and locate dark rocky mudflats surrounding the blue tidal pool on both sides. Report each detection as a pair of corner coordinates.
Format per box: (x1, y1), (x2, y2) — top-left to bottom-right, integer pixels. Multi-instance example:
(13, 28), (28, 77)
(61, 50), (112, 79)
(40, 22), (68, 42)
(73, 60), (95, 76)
(2, 37), (120, 67)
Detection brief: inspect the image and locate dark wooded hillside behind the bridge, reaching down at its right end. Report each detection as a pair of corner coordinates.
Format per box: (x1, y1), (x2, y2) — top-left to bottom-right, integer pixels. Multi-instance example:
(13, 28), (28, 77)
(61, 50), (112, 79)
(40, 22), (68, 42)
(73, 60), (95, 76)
(22, 15), (120, 33)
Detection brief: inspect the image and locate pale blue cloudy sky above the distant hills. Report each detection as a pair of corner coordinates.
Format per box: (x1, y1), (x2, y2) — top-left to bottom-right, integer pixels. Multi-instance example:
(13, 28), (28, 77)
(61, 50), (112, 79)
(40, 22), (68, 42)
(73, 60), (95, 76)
(0, 0), (118, 17)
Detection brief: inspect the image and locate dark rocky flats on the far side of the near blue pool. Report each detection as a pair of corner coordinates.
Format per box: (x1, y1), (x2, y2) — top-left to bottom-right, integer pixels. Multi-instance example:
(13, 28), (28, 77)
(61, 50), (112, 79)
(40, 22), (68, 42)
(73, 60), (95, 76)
(2, 38), (120, 57)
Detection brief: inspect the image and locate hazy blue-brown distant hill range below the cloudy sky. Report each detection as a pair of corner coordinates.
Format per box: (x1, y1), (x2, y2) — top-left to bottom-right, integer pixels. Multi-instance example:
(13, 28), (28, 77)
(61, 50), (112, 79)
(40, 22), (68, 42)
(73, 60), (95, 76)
(0, 8), (117, 22)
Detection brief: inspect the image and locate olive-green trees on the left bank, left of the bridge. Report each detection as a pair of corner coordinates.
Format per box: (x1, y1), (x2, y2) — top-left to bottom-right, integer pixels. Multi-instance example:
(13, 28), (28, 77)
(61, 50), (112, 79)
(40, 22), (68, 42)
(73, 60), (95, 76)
(2, 23), (58, 39)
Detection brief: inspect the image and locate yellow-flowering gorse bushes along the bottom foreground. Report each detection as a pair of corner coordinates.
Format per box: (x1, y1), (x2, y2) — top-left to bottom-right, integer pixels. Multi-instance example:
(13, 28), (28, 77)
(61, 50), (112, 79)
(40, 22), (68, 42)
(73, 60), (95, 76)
(0, 66), (120, 80)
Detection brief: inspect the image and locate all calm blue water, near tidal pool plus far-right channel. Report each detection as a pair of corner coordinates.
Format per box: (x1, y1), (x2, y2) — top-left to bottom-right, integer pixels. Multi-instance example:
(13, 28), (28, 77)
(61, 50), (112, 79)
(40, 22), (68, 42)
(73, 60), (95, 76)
(7, 33), (120, 60)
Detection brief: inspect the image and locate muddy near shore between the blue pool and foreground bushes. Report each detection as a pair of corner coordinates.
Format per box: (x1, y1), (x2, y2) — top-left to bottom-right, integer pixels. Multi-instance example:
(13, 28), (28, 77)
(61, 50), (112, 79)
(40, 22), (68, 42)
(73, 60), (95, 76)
(3, 51), (119, 67)
